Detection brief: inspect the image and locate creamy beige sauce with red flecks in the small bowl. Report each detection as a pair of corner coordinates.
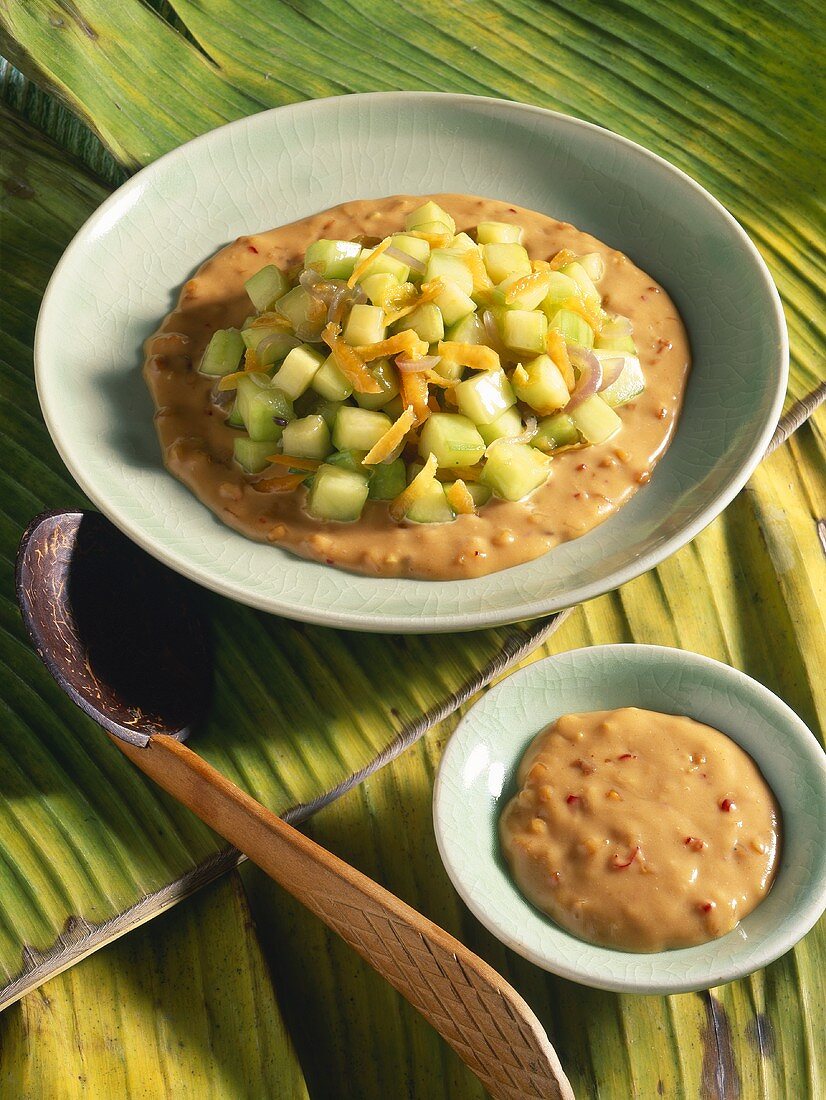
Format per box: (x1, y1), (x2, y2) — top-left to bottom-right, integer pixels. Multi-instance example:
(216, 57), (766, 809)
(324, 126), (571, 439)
(499, 707), (780, 952)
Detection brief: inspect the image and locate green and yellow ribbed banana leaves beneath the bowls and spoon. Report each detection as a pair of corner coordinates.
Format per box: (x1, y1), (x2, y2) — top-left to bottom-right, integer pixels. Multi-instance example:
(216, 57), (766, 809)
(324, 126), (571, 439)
(0, 0), (826, 1100)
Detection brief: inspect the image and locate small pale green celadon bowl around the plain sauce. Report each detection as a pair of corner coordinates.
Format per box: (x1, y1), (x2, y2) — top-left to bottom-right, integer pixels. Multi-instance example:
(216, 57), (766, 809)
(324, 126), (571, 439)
(433, 645), (826, 993)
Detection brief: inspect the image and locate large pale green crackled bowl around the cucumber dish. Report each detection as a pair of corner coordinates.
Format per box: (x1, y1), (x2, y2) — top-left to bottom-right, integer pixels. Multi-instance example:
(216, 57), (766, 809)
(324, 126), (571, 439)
(35, 92), (788, 633)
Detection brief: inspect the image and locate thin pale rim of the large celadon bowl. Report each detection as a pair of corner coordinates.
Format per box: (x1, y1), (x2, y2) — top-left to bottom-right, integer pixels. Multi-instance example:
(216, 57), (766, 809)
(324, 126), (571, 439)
(34, 90), (789, 634)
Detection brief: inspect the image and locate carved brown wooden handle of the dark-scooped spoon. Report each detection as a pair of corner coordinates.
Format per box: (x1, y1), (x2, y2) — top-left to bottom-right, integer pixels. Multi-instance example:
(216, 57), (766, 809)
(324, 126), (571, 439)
(112, 735), (573, 1100)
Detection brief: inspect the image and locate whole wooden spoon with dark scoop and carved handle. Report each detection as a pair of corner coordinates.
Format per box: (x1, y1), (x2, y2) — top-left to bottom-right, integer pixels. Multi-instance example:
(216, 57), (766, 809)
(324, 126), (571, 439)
(16, 512), (573, 1100)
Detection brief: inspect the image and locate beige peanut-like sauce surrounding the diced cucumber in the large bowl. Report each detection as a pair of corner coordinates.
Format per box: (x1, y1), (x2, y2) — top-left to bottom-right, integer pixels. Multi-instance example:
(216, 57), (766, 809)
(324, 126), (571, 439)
(144, 195), (689, 580)
